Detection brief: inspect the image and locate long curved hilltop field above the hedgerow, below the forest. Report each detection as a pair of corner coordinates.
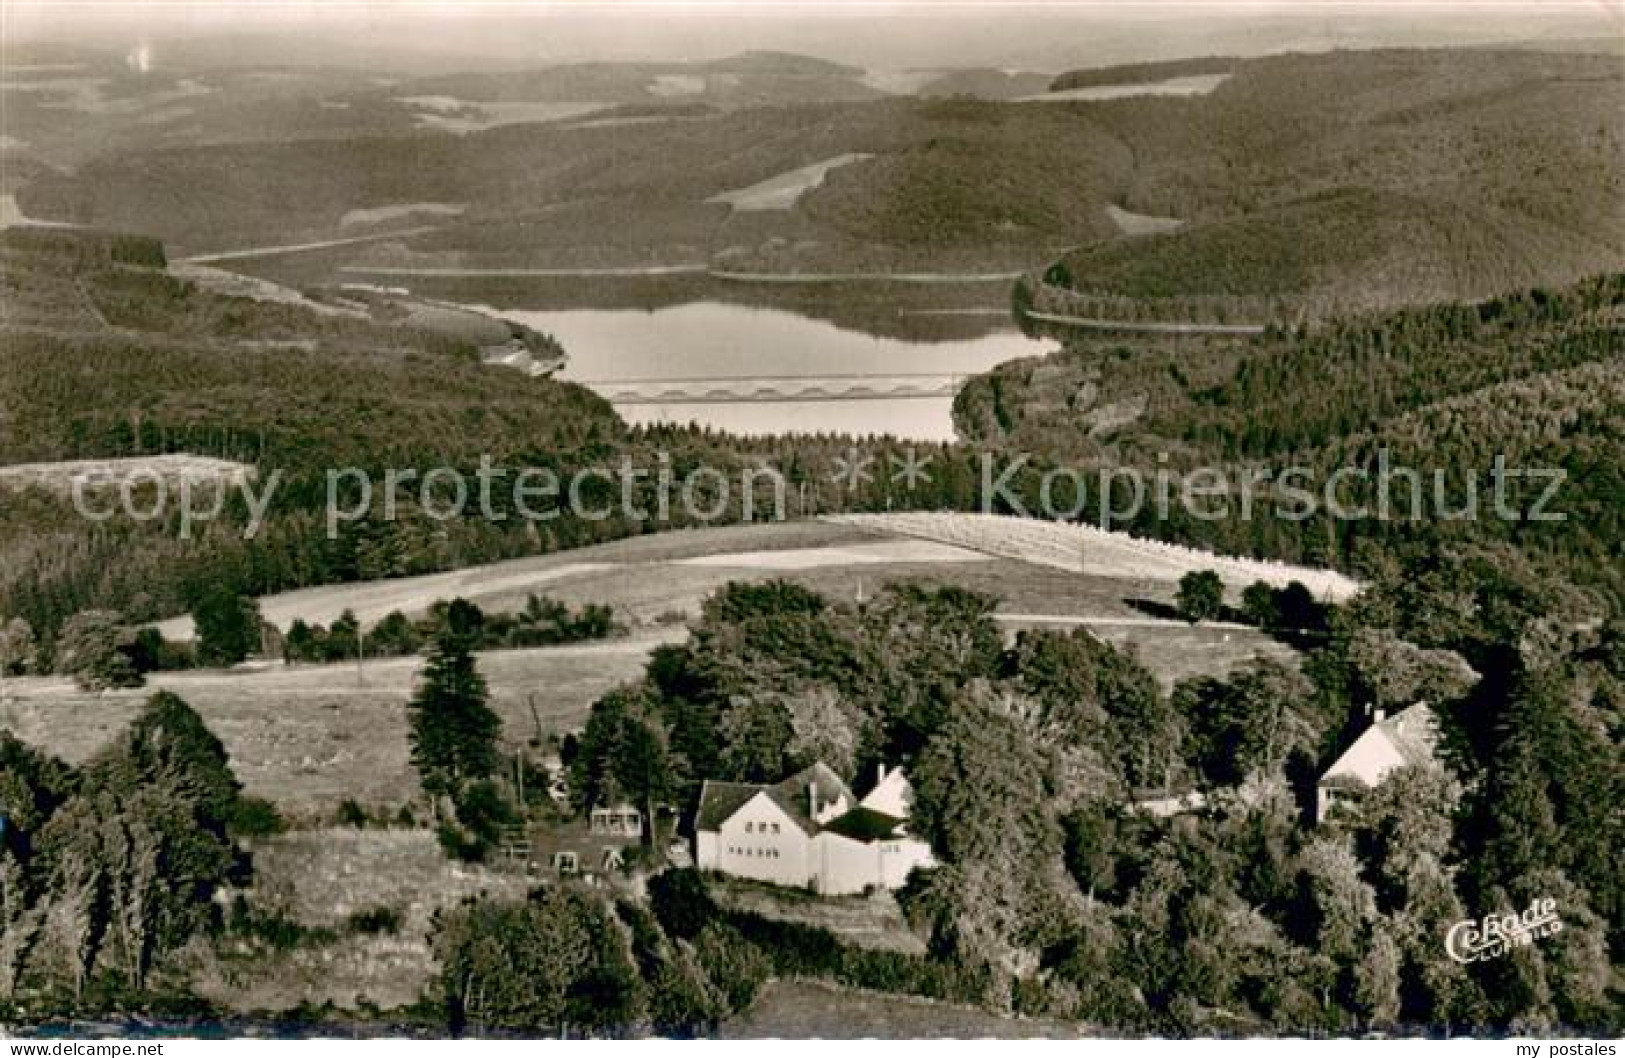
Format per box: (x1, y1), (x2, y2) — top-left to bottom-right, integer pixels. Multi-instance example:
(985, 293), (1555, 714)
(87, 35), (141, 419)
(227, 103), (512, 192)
(159, 515), (1292, 686)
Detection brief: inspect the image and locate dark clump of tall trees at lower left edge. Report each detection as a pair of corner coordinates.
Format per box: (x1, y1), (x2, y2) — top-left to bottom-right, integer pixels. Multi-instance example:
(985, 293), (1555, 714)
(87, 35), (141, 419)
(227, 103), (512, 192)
(0, 694), (275, 1011)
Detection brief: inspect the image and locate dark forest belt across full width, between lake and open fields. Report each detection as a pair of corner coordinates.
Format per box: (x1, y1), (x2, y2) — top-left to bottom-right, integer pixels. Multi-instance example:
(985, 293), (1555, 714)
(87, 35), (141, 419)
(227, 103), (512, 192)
(0, 236), (1625, 650)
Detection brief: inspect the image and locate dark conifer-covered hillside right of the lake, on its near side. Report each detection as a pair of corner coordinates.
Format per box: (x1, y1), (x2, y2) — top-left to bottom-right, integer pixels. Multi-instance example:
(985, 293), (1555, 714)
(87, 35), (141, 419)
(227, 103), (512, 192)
(956, 273), (1625, 595)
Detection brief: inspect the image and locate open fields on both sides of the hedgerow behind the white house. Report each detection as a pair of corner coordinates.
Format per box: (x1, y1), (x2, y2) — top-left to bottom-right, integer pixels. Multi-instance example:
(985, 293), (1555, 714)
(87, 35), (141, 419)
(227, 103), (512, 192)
(0, 515), (1292, 821)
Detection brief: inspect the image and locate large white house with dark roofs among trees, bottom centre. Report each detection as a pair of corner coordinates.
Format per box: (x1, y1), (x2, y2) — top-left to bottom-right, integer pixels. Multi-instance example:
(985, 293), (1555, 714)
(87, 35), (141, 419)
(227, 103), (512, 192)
(694, 762), (936, 895)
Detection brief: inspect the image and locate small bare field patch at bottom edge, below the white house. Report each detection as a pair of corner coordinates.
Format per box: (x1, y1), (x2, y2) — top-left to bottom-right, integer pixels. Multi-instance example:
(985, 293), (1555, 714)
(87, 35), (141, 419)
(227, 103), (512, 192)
(722, 980), (1084, 1040)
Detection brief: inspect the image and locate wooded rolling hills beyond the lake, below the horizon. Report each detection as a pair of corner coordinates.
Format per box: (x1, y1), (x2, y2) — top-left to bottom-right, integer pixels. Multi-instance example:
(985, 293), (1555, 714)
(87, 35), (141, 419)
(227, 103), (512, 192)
(18, 49), (1625, 312)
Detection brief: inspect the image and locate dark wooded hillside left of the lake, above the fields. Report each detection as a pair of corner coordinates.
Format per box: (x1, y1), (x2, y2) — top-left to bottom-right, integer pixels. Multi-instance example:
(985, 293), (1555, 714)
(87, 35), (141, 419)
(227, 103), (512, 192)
(0, 229), (626, 639)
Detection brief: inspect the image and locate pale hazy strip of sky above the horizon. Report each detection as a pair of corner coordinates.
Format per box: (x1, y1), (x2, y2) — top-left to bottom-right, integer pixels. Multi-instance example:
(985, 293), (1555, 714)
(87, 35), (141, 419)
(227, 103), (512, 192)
(0, 0), (1625, 70)
